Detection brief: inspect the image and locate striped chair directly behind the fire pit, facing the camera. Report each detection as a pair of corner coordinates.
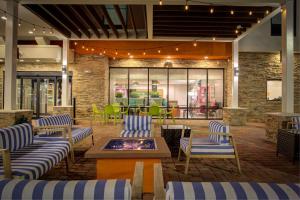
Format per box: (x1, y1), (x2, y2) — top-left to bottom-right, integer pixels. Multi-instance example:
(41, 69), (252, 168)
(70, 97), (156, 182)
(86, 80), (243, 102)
(120, 115), (152, 137)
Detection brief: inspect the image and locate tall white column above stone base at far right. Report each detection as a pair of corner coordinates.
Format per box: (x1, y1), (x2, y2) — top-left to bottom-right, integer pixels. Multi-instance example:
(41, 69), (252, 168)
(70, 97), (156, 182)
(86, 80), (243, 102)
(281, 0), (294, 113)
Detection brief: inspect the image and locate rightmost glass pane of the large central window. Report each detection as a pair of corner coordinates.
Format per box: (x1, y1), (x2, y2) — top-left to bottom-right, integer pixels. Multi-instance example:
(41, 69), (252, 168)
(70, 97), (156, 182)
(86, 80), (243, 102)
(208, 69), (224, 118)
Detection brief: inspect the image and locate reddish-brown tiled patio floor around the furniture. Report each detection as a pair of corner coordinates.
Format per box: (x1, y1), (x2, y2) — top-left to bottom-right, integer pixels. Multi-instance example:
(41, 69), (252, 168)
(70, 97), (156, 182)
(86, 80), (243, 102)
(41, 120), (300, 183)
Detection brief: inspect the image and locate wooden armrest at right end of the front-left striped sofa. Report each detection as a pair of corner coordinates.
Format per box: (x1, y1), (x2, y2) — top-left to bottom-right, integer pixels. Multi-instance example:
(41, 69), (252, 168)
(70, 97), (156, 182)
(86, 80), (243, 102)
(132, 162), (144, 199)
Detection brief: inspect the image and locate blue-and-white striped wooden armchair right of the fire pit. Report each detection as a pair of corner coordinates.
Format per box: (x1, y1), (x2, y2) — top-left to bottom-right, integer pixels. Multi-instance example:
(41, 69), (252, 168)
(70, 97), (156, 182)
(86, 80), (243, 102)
(178, 121), (241, 174)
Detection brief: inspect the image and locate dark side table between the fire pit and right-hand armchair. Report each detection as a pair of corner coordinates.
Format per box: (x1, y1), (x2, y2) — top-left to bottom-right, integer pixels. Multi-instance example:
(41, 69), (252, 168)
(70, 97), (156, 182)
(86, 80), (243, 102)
(161, 125), (191, 157)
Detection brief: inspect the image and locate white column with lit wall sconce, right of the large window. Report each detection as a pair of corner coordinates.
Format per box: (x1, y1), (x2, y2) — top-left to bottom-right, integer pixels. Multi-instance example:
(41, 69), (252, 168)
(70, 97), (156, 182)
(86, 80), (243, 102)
(231, 40), (239, 108)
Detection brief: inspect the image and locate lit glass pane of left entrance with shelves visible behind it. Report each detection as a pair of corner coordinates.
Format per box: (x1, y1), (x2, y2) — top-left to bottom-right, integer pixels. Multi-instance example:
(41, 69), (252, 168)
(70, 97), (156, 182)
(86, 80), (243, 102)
(39, 79), (55, 116)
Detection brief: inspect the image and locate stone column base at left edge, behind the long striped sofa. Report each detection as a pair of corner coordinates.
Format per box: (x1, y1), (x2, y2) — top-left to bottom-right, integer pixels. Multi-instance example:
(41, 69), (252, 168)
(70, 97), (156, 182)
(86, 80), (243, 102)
(0, 110), (33, 128)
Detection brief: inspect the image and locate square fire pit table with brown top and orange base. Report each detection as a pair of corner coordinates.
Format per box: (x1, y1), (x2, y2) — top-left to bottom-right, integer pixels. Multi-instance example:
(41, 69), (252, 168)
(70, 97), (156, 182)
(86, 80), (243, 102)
(85, 137), (171, 193)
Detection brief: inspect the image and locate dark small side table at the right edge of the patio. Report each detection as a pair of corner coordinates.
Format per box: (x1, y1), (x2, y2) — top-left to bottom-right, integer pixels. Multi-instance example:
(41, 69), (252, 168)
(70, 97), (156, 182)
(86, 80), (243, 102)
(277, 129), (300, 162)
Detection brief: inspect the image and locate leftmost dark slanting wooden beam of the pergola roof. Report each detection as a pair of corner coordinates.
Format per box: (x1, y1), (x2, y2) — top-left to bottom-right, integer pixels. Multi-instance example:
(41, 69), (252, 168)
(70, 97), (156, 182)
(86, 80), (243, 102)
(24, 4), (72, 38)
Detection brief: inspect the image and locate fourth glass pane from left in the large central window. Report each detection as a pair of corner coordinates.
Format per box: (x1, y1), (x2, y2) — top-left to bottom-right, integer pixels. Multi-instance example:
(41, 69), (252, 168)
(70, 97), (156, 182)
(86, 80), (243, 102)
(169, 69), (188, 118)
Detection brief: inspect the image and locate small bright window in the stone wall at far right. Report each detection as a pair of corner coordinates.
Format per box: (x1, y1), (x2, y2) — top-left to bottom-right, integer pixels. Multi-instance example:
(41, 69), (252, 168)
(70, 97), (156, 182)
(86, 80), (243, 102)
(267, 80), (282, 101)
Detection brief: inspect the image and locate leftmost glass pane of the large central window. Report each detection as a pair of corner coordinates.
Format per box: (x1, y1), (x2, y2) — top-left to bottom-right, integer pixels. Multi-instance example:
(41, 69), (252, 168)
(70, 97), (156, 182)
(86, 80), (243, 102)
(110, 69), (128, 106)
